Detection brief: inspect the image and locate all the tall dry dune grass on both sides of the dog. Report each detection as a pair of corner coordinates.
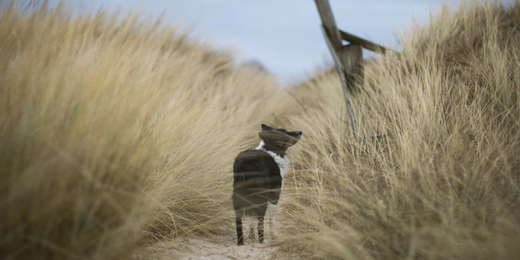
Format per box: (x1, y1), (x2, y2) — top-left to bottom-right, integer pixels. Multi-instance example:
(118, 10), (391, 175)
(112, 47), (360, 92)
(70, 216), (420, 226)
(0, 1), (520, 259)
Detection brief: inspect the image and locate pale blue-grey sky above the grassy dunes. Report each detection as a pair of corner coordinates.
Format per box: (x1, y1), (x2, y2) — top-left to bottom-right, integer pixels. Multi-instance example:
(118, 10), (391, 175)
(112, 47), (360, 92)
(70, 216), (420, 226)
(22, 0), (468, 83)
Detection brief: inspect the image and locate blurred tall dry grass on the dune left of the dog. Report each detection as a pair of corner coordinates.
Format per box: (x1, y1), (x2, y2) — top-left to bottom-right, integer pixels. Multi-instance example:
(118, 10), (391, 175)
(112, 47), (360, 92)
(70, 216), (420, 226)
(0, 1), (291, 259)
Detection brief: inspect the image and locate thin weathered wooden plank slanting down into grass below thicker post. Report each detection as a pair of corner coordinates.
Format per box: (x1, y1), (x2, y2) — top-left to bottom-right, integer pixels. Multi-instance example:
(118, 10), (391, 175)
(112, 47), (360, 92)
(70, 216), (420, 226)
(321, 25), (359, 137)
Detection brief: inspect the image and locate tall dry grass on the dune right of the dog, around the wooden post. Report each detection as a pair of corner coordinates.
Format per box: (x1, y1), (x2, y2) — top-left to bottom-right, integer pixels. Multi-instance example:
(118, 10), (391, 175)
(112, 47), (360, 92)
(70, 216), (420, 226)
(282, 1), (520, 259)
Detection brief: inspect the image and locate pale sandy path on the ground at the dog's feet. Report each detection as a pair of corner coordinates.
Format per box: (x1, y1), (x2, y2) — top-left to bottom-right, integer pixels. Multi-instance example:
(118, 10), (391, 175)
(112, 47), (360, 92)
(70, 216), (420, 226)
(137, 226), (277, 260)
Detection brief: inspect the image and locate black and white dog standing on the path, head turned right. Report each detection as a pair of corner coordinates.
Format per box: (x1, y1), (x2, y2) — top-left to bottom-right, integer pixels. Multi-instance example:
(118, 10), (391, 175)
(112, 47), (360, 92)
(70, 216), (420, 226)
(232, 124), (302, 245)
